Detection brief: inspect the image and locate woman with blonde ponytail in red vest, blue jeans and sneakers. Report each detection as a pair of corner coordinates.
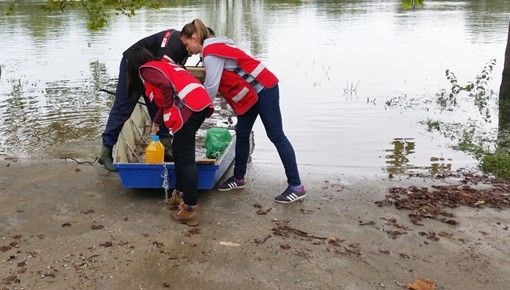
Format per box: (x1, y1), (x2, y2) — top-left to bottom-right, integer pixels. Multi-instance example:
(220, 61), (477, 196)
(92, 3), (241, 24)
(181, 19), (306, 203)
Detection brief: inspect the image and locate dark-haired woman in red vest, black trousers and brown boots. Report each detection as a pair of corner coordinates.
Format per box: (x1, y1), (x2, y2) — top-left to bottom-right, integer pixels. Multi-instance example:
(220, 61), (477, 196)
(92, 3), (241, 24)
(126, 46), (214, 226)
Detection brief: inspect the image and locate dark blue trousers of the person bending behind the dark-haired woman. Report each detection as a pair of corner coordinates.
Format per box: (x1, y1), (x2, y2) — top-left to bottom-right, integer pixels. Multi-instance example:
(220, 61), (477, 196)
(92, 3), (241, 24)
(102, 57), (168, 148)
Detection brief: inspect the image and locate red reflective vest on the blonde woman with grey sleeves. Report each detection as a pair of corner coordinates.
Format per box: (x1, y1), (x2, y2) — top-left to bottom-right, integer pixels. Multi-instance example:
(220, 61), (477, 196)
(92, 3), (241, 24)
(202, 42), (278, 115)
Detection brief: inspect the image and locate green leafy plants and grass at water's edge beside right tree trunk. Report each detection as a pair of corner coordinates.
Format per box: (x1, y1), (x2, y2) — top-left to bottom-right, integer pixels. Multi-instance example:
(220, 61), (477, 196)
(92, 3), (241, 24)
(385, 59), (510, 180)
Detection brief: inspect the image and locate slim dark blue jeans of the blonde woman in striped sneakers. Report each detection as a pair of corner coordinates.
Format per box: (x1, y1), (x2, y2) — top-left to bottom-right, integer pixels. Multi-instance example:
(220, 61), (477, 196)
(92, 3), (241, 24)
(234, 85), (301, 186)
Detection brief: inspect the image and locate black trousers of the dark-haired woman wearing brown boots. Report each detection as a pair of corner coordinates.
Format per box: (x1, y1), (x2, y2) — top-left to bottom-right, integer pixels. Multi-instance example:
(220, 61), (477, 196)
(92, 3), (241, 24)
(172, 109), (209, 205)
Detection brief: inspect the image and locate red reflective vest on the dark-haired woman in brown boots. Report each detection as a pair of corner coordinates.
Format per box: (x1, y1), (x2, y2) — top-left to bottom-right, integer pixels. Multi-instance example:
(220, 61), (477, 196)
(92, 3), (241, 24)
(140, 60), (214, 133)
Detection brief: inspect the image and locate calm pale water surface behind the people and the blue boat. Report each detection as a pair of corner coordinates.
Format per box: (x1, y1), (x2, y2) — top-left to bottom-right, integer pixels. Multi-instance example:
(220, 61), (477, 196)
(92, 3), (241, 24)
(0, 0), (510, 174)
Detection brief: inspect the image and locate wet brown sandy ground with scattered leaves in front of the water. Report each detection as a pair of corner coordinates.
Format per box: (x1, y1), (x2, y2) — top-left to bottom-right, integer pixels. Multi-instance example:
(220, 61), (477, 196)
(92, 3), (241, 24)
(0, 159), (510, 289)
